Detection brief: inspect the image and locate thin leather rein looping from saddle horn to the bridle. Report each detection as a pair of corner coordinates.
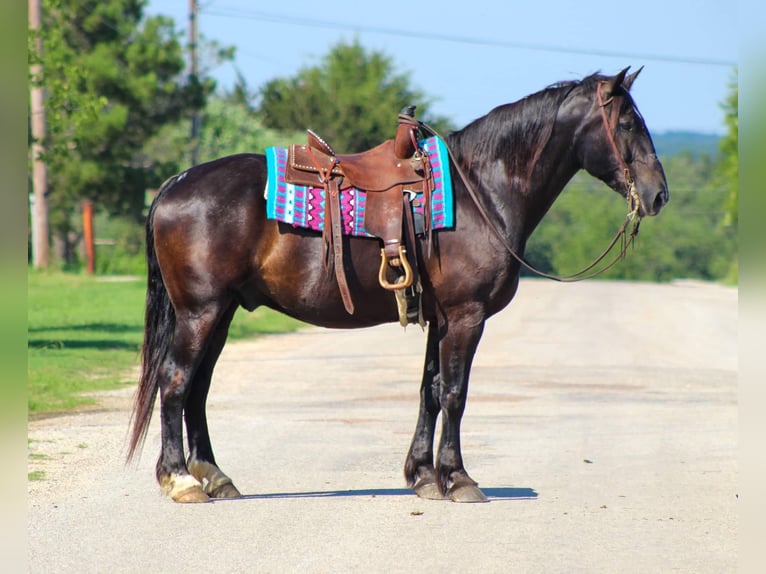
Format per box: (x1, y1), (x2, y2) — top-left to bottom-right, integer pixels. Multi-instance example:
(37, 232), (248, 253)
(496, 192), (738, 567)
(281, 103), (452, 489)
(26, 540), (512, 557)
(420, 84), (641, 283)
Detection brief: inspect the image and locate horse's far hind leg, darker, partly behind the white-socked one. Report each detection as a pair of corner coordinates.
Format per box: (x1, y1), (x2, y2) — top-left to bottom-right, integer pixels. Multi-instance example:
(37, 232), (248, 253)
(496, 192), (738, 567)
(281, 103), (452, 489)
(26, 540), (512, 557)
(184, 303), (241, 498)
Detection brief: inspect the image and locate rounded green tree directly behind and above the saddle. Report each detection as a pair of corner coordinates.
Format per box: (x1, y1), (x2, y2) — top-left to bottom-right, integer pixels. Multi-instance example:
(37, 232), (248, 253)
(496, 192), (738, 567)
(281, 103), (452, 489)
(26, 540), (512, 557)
(258, 41), (451, 152)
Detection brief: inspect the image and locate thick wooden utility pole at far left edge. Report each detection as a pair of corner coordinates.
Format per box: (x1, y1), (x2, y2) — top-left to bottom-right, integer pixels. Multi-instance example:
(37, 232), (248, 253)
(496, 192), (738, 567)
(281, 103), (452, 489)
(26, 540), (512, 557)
(28, 0), (50, 269)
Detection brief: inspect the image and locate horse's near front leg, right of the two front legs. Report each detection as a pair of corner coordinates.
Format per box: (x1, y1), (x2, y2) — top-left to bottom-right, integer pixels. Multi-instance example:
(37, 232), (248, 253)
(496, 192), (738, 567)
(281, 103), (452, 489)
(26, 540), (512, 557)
(436, 309), (487, 502)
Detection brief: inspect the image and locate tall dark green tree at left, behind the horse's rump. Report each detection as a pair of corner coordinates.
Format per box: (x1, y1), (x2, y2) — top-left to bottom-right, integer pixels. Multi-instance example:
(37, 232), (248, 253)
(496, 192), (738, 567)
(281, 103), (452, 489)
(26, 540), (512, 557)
(30, 0), (220, 264)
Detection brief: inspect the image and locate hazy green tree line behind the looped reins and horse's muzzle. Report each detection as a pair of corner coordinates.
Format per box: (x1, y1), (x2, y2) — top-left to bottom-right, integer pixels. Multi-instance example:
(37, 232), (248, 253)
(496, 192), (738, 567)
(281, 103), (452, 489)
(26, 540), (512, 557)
(526, 154), (736, 281)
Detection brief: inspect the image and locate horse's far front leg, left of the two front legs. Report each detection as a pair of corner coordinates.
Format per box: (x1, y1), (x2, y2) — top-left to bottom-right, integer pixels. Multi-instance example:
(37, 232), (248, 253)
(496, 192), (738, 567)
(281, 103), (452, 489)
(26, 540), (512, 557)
(404, 322), (444, 500)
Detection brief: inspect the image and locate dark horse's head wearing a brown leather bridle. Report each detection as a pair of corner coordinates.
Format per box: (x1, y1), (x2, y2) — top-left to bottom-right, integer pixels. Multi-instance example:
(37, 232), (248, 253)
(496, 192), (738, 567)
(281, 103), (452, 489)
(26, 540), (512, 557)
(570, 68), (670, 216)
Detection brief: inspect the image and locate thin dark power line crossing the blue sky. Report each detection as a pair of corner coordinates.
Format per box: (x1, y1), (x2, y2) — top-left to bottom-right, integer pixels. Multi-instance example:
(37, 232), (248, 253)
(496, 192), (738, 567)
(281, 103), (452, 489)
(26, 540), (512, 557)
(205, 6), (737, 68)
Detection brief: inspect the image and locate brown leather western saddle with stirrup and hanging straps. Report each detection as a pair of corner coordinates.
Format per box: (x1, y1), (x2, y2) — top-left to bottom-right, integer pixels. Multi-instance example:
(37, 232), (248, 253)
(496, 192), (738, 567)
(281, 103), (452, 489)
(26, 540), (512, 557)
(285, 106), (433, 326)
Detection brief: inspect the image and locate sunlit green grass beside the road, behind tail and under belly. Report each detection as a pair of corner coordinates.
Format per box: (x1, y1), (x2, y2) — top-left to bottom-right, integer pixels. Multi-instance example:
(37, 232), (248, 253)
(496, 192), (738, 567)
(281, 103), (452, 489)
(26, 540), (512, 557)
(27, 271), (301, 414)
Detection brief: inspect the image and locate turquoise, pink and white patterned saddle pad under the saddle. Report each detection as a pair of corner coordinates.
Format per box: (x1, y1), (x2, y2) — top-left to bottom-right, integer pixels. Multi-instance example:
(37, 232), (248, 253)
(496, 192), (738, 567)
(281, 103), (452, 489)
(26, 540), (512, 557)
(266, 137), (455, 237)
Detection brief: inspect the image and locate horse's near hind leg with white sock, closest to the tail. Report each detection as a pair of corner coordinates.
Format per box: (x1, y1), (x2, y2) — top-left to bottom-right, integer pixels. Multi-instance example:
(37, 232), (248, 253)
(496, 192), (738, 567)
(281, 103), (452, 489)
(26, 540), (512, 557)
(156, 304), (230, 502)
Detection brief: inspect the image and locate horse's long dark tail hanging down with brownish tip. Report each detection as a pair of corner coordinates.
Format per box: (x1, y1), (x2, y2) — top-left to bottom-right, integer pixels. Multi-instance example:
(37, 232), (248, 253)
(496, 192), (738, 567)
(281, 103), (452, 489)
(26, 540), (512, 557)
(127, 176), (177, 462)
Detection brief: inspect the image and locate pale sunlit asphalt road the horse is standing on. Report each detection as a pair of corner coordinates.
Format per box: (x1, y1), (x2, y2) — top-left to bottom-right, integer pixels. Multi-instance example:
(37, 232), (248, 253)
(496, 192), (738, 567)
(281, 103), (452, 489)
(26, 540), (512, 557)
(28, 280), (738, 574)
